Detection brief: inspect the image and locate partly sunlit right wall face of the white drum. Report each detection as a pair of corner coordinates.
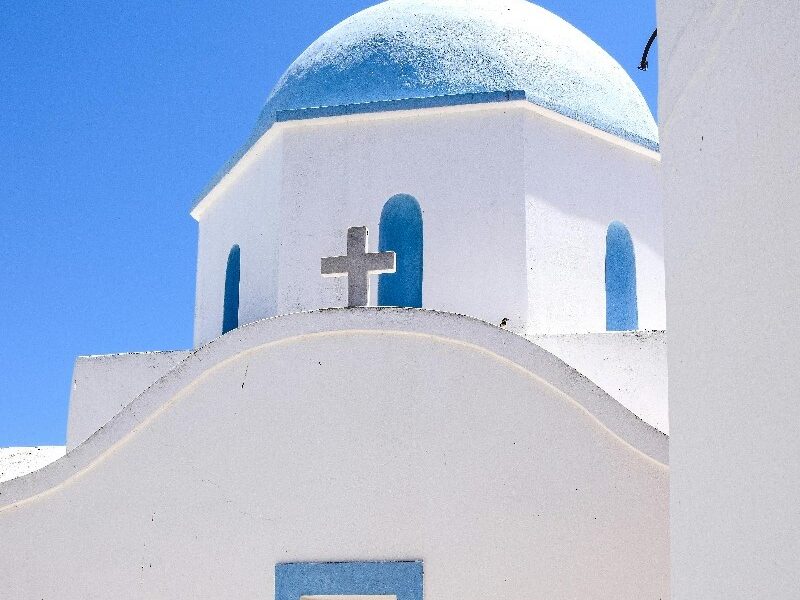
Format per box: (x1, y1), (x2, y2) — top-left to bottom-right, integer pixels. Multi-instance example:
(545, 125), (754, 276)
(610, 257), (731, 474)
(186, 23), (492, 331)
(525, 110), (665, 333)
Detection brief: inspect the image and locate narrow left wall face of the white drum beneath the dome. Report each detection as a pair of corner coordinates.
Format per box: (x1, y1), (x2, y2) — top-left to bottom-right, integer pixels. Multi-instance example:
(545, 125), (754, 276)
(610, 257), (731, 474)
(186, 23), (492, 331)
(193, 132), (283, 346)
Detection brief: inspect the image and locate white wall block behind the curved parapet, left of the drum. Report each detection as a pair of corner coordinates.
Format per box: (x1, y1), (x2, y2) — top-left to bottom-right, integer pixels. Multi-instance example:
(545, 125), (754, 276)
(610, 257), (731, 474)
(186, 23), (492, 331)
(67, 351), (189, 451)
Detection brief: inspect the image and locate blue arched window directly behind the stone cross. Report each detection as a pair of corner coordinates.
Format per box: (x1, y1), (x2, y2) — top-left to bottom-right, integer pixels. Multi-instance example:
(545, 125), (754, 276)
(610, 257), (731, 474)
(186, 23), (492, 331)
(378, 194), (422, 308)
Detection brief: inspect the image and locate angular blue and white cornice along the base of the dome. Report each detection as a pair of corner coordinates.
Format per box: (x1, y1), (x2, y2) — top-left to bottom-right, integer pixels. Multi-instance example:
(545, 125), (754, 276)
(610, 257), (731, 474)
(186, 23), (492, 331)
(190, 90), (659, 219)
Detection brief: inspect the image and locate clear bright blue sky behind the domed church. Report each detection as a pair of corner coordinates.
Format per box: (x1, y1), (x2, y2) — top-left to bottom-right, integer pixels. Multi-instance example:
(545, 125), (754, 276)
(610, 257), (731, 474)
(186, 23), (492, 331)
(0, 0), (657, 447)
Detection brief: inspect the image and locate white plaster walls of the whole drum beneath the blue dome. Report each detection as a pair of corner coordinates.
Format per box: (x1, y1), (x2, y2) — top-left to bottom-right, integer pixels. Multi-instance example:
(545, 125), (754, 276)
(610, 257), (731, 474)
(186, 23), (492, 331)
(193, 101), (664, 344)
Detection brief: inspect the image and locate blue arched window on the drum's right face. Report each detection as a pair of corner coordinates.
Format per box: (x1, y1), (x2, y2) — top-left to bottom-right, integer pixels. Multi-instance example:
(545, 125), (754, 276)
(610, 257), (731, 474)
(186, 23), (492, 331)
(606, 221), (639, 331)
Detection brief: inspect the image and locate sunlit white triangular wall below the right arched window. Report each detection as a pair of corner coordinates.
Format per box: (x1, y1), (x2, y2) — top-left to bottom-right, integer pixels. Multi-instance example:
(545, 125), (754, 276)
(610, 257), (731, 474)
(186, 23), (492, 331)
(526, 331), (669, 434)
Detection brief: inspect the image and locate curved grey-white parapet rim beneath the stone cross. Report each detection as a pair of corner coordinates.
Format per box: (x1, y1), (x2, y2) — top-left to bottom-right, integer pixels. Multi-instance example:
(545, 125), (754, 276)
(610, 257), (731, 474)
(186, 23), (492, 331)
(0, 308), (669, 511)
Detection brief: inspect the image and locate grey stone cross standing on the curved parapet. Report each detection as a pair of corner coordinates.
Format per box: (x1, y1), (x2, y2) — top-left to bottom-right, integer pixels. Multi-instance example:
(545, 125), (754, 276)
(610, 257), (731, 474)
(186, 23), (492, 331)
(322, 227), (395, 307)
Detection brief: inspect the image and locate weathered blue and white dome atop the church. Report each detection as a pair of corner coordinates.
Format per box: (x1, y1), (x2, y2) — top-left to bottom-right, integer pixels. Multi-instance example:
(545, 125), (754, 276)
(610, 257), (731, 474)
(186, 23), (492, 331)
(253, 0), (658, 149)
